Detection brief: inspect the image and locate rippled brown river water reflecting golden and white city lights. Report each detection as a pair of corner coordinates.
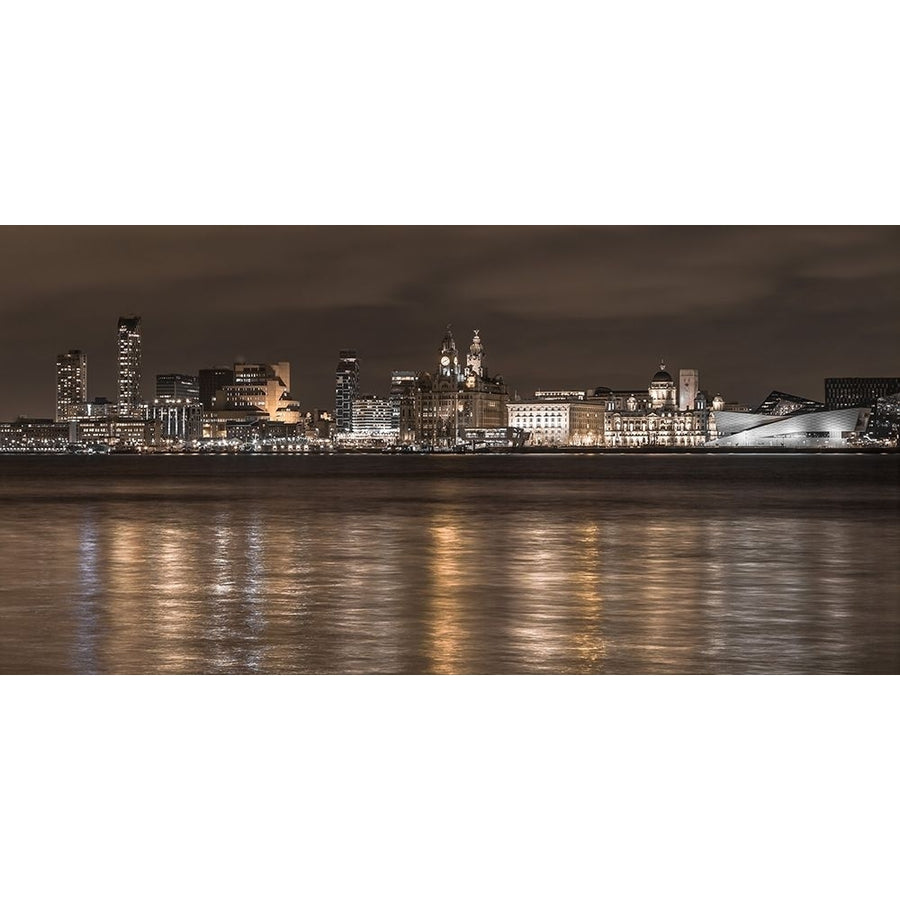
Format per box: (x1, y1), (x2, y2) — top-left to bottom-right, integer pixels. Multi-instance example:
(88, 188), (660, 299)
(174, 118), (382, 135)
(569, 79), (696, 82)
(0, 454), (900, 673)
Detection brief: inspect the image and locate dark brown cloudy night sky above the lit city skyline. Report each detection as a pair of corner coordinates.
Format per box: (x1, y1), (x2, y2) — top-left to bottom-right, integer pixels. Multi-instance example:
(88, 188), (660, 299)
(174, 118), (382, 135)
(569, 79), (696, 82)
(0, 226), (900, 421)
